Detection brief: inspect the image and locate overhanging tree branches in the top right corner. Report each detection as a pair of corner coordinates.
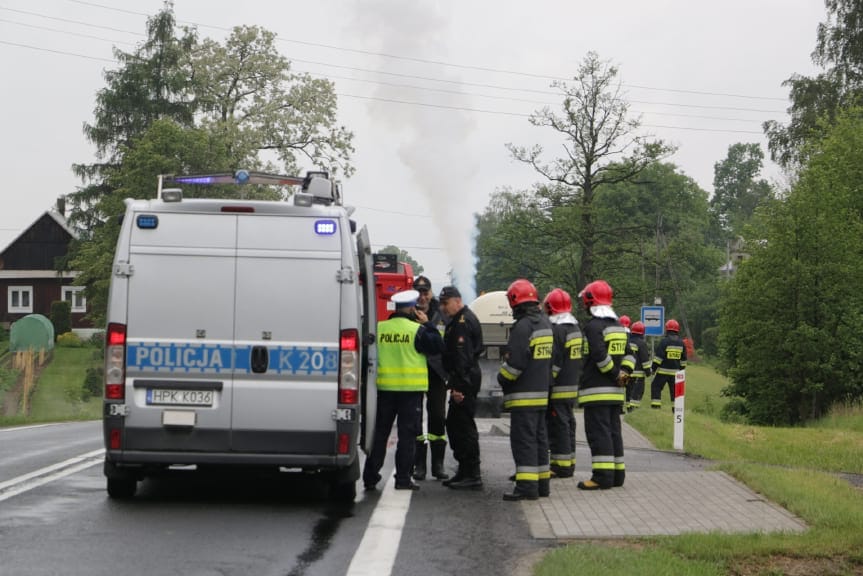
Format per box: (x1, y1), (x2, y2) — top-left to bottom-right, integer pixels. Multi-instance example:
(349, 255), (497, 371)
(763, 0), (863, 169)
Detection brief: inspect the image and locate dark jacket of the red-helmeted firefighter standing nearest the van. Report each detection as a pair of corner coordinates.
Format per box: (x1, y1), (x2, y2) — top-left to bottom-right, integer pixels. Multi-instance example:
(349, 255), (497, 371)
(497, 303), (554, 410)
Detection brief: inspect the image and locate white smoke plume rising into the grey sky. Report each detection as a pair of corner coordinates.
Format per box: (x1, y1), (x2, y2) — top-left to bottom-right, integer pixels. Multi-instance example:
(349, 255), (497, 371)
(358, 0), (480, 303)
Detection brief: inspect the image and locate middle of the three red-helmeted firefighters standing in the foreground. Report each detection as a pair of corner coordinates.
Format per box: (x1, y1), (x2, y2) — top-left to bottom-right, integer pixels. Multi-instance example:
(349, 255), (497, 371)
(542, 288), (582, 478)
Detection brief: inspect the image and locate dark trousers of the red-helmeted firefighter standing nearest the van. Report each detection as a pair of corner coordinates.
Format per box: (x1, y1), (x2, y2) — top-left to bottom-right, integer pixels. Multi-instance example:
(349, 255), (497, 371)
(509, 408), (551, 496)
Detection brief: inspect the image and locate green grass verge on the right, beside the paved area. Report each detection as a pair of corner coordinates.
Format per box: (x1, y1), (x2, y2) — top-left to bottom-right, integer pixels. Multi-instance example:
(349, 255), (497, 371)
(534, 366), (863, 576)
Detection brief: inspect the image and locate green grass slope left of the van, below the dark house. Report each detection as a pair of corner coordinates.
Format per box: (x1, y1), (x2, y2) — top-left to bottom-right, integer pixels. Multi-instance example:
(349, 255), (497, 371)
(0, 347), (102, 426)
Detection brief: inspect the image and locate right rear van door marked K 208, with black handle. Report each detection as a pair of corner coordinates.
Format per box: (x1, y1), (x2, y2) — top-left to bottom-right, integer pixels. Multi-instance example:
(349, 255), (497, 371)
(231, 214), (342, 455)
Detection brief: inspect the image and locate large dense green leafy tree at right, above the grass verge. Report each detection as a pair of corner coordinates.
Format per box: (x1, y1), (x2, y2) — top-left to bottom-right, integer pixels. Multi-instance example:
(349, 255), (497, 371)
(721, 108), (863, 425)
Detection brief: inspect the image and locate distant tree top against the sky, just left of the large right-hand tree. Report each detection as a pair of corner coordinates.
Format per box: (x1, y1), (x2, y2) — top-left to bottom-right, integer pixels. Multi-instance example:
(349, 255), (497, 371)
(710, 142), (772, 238)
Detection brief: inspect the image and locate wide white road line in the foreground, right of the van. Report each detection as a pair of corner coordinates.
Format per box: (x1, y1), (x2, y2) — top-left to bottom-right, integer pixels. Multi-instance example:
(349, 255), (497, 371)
(347, 481), (413, 576)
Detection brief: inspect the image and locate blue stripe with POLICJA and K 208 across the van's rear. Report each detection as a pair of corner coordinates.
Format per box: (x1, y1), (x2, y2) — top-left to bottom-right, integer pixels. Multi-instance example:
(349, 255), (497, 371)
(126, 342), (339, 376)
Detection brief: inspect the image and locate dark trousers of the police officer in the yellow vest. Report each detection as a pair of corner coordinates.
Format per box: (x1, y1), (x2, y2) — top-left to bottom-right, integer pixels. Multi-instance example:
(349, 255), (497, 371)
(363, 390), (423, 485)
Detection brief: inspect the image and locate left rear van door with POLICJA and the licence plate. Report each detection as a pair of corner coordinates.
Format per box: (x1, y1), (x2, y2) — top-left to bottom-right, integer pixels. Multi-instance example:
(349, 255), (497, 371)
(125, 212), (237, 452)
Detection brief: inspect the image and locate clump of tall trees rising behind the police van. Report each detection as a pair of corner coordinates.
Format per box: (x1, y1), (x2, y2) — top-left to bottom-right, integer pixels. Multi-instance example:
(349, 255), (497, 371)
(63, 2), (353, 322)
